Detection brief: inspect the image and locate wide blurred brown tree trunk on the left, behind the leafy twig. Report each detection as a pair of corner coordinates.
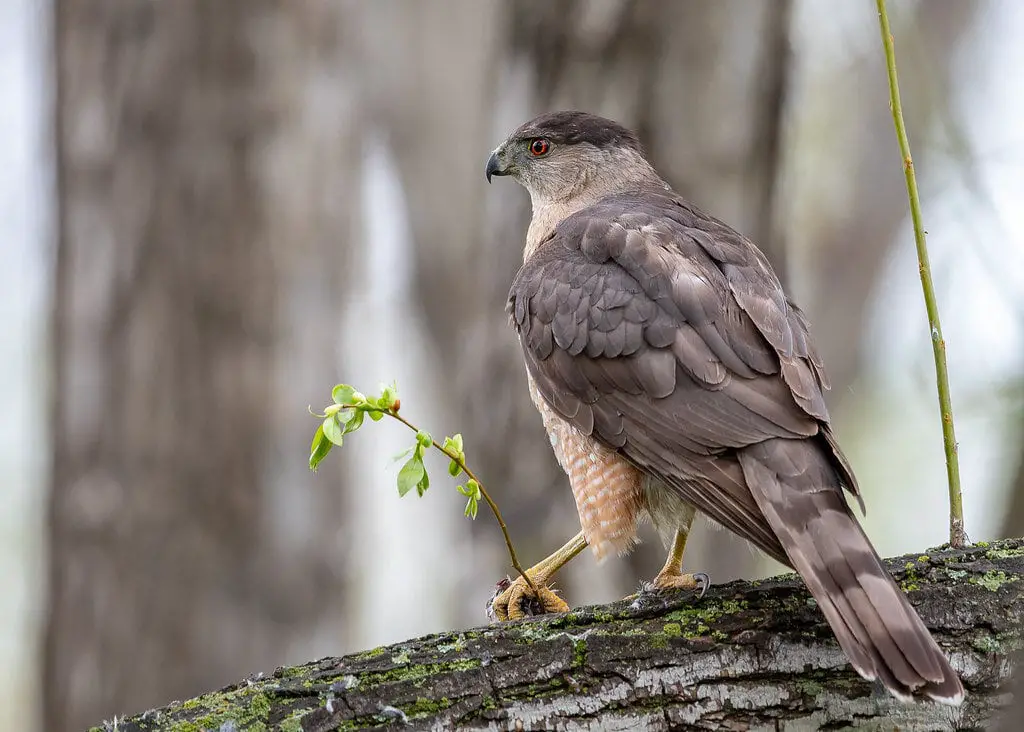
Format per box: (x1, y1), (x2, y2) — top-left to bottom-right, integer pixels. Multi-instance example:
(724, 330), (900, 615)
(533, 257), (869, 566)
(42, 0), (357, 732)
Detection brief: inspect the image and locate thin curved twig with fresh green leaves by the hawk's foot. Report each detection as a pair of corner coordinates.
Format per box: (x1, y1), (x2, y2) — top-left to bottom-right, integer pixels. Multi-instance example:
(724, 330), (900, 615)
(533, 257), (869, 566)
(309, 384), (541, 598)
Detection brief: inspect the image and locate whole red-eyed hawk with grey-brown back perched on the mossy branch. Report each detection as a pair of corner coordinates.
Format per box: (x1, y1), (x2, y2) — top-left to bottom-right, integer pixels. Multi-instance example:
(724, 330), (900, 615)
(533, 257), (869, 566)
(486, 112), (964, 704)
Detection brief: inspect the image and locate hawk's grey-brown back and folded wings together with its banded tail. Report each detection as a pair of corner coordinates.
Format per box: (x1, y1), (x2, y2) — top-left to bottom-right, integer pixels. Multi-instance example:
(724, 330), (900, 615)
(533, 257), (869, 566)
(509, 190), (963, 702)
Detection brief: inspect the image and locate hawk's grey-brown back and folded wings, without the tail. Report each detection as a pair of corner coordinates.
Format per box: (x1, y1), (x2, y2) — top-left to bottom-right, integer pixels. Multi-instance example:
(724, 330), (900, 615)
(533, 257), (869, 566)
(509, 187), (856, 561)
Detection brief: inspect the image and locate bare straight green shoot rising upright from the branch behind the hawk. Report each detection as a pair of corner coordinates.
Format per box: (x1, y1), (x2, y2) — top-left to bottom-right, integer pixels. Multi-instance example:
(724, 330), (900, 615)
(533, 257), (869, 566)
(877, 0), (967, 547)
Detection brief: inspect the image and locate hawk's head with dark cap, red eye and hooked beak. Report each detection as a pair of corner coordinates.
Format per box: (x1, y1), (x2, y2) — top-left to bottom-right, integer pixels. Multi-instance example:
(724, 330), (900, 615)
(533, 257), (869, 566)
(484, 112), (650, 202)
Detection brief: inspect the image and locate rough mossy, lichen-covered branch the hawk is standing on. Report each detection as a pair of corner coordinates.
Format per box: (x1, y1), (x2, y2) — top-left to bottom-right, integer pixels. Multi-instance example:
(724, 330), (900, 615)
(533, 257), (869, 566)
(93, 540), (1024, 732)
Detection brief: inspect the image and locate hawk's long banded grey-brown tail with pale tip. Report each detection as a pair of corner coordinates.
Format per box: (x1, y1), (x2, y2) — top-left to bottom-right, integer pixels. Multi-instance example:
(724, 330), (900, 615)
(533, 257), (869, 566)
(739, 439), (964, 704)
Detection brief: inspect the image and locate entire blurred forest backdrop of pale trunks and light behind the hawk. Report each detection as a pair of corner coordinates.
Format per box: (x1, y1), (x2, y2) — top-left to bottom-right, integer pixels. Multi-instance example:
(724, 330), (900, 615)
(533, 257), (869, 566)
(0, 0), (1024, 732)
